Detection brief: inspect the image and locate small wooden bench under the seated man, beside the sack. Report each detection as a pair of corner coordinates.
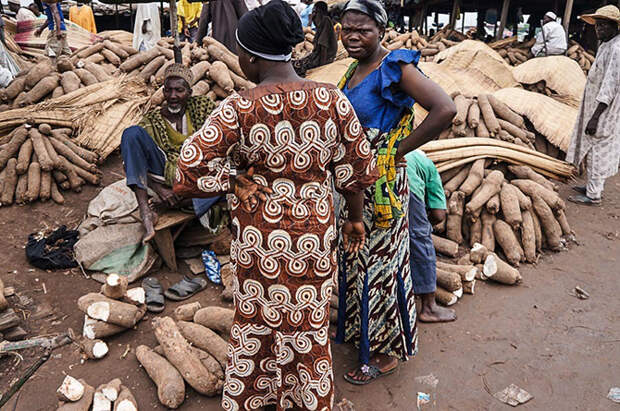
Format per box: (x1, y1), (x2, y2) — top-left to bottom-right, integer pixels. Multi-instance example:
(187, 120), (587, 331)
(154, 210), (195, 271)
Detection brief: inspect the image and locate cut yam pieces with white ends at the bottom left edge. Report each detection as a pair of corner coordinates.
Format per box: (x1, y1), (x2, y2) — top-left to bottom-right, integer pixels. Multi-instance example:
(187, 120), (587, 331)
(56, 375), (138, 411)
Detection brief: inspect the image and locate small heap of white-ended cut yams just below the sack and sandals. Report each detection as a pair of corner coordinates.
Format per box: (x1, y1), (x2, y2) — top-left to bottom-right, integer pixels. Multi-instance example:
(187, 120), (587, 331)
(74, 274), (146, 359)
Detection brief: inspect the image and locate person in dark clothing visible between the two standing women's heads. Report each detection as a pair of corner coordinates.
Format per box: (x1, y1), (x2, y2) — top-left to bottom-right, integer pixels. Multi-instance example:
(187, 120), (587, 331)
(293, 1), (338, 77)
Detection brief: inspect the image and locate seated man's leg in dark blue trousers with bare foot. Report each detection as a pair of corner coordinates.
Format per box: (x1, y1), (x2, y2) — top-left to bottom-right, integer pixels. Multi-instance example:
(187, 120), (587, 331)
(121, 126), (166, 244)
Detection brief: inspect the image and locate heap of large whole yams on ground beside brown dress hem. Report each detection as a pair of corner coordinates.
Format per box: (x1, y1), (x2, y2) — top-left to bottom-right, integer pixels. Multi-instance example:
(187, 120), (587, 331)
(136, 302), (234, 408)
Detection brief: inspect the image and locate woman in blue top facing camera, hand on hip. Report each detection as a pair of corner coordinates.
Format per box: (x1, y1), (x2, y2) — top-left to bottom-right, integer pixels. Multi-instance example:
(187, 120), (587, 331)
(336, 0), (456, 384)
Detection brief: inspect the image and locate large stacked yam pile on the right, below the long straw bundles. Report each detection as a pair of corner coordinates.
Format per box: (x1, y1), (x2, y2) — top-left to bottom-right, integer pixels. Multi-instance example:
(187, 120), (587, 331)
(434, 159), (573, 280)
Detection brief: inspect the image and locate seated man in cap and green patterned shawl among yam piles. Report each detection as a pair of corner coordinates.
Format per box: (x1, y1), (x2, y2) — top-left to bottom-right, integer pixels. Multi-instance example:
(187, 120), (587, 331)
(121, 64), (217, 244)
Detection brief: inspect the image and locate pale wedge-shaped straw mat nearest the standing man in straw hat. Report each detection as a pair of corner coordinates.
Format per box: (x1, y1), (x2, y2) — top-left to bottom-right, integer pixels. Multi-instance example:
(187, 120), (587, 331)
(493, 88), (578, 152)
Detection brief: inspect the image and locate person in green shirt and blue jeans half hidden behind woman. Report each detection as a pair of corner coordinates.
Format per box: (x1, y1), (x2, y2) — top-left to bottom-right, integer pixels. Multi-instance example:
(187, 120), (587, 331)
(405, 150), (456, 323)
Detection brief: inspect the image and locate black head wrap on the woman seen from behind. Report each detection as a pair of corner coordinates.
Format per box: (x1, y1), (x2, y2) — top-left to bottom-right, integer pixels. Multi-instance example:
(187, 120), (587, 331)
(237, 0), (304, 61)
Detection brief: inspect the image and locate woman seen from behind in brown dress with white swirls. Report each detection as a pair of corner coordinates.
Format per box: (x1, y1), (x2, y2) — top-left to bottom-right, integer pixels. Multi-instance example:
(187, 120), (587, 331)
(174, 0), (377, 410)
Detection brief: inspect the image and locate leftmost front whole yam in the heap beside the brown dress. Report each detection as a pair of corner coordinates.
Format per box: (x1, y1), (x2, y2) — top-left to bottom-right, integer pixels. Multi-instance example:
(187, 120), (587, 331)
(136, 345), (185, 409)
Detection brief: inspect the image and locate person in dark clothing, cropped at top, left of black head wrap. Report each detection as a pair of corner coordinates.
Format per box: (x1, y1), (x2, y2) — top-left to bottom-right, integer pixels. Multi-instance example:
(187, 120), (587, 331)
(198, 0), (248, 54)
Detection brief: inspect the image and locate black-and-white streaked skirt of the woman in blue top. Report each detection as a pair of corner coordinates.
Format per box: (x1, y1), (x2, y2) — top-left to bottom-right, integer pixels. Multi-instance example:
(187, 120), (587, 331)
(337, 161), (417, 364)
